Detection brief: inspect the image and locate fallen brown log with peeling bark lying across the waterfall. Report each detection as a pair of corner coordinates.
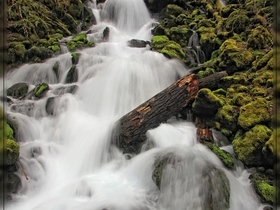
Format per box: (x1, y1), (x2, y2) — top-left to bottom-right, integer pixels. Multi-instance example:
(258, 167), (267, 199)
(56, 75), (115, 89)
(112, 72), (227, 153)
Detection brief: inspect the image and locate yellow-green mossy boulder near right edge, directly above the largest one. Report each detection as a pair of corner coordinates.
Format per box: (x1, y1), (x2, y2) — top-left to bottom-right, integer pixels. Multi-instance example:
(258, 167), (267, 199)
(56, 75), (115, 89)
(238, 98), (271, 130)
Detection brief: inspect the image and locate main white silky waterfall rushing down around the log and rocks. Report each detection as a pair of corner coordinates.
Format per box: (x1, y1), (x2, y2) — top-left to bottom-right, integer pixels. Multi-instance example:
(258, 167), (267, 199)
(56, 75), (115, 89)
(6, 0), (266, 210)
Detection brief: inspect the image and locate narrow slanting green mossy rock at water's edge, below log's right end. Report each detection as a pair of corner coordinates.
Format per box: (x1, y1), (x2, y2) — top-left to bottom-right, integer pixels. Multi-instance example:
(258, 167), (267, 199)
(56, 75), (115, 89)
(204, 142), (235, 170)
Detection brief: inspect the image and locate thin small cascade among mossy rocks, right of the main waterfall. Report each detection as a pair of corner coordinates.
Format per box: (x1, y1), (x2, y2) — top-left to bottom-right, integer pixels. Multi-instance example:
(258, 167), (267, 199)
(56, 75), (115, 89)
(184, 30), (205, 66)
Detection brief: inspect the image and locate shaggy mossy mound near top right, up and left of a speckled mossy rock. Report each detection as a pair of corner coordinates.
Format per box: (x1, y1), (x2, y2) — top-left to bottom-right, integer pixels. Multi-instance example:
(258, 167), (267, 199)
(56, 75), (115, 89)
(225, 9), (250, 34)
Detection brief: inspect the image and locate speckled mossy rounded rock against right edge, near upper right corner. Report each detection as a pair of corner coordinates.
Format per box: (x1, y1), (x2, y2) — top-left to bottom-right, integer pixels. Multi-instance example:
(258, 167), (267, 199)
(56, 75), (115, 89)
(247, 25), (273, 49)
